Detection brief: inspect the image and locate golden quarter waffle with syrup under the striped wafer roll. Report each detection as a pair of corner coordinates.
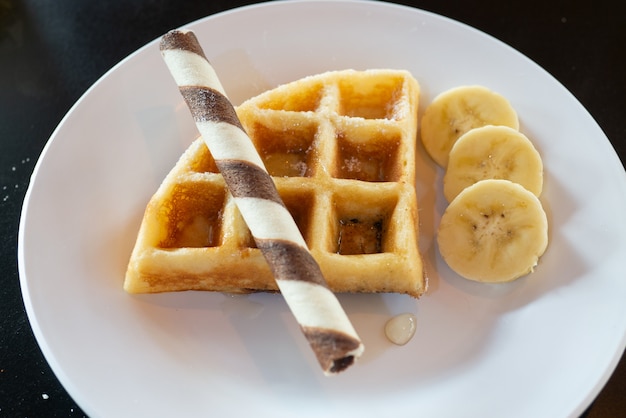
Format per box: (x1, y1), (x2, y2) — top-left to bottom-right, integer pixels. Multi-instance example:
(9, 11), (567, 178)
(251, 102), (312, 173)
(124, 70), (426, 297)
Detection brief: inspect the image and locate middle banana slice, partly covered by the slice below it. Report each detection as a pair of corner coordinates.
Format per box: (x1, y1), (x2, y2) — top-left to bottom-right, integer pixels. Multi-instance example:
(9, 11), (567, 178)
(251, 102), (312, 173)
(443, 125), (543, 202)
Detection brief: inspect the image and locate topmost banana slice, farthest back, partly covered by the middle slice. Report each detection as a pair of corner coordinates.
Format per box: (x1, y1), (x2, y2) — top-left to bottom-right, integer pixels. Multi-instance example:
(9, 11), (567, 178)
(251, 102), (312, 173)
(421, 86), (519, 168)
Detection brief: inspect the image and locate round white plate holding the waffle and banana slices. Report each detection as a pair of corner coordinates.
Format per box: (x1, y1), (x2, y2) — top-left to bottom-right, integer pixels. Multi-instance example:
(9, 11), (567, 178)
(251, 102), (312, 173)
(19, 1), (626, 417)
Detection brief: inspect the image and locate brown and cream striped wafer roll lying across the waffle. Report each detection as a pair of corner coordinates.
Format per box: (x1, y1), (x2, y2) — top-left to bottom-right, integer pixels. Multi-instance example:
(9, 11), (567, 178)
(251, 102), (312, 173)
(161, 31), (363, 374)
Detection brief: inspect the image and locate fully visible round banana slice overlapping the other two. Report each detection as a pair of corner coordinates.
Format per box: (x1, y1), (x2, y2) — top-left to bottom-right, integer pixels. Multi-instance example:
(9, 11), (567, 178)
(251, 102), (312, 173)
(437, 179), (548, 283)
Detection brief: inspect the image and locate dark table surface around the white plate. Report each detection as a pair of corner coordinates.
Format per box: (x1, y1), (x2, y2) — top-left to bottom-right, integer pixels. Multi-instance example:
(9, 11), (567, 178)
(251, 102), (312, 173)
(0, 0), (626, 418)
